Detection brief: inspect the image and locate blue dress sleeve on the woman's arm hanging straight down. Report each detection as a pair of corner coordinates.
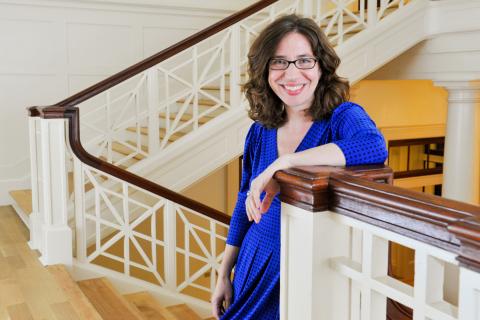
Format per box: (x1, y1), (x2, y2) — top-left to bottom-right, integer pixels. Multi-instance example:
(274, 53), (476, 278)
(227, 123), (257, 247)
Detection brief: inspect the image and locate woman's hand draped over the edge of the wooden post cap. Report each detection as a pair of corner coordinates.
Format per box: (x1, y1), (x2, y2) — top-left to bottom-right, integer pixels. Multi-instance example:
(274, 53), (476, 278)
(245, 156), (289, 223)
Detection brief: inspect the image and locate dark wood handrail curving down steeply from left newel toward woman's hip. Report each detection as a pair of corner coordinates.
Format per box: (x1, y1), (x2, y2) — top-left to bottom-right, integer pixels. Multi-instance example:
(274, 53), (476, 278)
(29, 107), (230, 224)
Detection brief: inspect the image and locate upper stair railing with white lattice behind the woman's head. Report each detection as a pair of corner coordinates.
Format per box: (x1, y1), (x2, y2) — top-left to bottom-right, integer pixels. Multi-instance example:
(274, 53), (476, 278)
(29, 0), (411, 174)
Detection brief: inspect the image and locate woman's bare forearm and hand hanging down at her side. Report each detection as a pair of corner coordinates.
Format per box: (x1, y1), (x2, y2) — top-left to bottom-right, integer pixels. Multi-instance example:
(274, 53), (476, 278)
(212, 244), (239, 319)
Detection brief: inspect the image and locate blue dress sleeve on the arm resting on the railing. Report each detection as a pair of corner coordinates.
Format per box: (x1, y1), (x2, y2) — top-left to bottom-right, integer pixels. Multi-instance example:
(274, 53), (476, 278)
(331, 103), (387, 166)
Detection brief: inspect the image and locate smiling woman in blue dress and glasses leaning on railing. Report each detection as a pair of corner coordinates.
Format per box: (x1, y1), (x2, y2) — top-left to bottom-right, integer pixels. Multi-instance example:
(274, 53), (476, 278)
(212, 15), (387, 320)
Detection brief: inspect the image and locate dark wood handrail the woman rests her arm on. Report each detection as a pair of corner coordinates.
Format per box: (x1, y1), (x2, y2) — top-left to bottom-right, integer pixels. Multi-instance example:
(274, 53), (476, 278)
(275, 167), (480, 272)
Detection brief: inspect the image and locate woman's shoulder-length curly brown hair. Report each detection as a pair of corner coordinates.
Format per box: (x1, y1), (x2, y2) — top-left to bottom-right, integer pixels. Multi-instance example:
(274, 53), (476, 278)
(244, 14), (350, 128)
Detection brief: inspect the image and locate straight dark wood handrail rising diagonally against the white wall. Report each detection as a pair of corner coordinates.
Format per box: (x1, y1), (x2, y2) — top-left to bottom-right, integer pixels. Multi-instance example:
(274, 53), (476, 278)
(48, 0), (278, 107)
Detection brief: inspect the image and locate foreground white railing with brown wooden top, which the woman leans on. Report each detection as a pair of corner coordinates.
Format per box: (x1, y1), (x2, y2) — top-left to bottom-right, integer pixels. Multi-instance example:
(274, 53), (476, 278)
(276, 168), (480, 320)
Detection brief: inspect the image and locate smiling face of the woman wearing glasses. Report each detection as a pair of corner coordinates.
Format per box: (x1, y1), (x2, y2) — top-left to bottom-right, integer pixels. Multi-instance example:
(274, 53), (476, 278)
(268, 32), (321, 110)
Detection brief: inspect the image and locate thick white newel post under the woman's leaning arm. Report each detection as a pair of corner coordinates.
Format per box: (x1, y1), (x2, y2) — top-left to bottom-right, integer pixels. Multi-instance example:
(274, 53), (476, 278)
(280, 203), (350, 320)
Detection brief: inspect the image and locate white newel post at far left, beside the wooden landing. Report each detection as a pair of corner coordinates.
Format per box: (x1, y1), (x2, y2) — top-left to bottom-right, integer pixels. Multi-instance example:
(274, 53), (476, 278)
(36, 119), (72, 265)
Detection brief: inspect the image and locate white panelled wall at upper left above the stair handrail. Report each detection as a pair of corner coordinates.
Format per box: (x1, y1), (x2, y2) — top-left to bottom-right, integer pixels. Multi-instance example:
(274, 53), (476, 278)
(0, 0), (254, 205)
